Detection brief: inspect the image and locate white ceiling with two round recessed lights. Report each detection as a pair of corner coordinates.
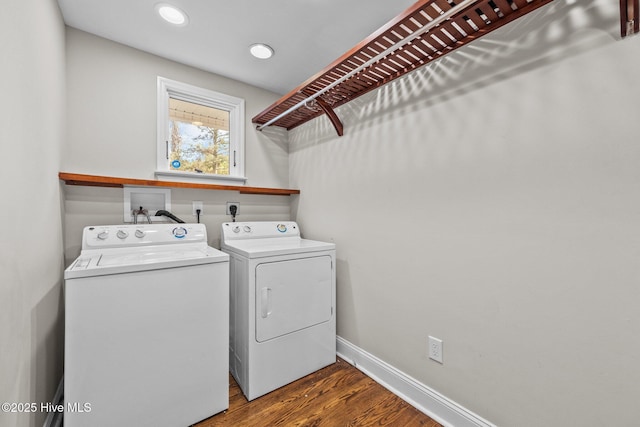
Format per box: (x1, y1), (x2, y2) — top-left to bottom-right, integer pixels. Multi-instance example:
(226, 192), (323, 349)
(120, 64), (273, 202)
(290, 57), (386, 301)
(58, 0), (414, 94)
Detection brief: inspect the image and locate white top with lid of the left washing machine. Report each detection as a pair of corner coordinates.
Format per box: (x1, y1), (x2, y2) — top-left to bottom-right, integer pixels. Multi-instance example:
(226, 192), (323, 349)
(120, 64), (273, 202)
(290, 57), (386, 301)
(64, 245), (229, 279)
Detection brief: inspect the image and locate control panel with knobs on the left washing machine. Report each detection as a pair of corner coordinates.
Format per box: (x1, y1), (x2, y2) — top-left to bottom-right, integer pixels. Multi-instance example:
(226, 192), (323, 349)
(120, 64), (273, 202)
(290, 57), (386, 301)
(82, 224), (207, 250)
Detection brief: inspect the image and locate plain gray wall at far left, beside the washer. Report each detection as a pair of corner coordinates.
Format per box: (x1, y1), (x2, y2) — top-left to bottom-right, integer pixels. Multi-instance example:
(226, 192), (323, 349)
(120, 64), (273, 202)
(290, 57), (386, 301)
(0, 0), (65, 427)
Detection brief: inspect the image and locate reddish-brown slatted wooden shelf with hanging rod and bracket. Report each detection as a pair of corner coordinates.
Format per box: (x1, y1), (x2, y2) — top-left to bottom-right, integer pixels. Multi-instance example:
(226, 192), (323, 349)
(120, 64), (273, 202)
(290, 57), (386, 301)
(252, 0), (552, 135)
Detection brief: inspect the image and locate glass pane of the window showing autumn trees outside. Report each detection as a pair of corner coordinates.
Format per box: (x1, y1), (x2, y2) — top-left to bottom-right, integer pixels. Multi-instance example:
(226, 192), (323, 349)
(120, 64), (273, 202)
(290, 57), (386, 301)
(169, 98), (229, 175)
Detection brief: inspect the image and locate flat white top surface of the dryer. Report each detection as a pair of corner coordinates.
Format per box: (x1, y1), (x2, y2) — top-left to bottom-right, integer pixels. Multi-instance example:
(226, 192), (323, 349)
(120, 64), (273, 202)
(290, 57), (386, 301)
(222, 237), (336, 258)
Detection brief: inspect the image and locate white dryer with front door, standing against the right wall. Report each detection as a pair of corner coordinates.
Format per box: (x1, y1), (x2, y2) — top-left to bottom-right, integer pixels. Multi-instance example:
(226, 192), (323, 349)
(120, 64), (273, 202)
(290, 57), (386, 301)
(221, 222), (336, 400)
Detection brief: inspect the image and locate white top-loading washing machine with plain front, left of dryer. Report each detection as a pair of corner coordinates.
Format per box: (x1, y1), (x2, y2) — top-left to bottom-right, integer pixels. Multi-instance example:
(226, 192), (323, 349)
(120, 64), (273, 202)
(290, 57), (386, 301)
(64, 224), (229, 427)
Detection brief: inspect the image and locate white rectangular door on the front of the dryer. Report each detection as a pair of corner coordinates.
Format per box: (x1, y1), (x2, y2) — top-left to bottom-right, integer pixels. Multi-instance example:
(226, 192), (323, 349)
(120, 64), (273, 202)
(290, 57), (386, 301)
(256, 255), (332, 342)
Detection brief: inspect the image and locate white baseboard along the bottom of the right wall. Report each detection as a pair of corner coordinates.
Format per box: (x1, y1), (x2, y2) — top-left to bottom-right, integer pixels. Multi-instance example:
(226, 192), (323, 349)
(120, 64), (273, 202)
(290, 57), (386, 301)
(336, 337), (496, 427)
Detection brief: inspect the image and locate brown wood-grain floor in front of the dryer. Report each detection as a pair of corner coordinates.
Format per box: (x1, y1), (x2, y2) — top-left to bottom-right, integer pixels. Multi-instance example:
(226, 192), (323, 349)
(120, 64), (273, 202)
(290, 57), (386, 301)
(195, 359), (441, 427)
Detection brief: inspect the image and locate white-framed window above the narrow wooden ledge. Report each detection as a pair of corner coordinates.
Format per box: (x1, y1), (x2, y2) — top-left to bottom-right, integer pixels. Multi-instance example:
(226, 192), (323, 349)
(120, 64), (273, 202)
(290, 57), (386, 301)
(156, 77), (246, 181)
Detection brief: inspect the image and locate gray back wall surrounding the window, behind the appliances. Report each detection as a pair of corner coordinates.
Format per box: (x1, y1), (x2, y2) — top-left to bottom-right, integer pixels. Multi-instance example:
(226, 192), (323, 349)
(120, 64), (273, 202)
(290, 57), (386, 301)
(62, 27), (290, 263)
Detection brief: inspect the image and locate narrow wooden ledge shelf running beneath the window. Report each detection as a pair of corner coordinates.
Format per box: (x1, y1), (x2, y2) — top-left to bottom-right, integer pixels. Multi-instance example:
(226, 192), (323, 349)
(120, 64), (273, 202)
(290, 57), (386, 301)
(58, 172), (300, 196)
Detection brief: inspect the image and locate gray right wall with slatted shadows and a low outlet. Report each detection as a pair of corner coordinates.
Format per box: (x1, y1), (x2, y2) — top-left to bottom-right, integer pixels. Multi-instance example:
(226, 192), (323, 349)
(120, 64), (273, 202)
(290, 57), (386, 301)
(289, 0), (640, 427)
